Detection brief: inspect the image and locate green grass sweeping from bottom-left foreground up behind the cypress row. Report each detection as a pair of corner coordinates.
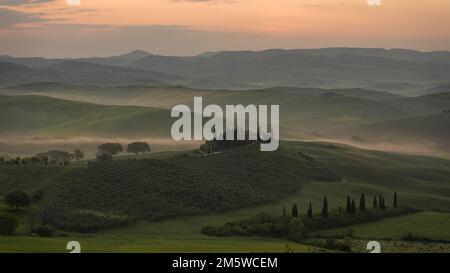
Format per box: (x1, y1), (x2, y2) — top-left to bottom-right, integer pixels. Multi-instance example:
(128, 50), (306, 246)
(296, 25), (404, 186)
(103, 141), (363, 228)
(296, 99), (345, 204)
(0, 142), (450, 252)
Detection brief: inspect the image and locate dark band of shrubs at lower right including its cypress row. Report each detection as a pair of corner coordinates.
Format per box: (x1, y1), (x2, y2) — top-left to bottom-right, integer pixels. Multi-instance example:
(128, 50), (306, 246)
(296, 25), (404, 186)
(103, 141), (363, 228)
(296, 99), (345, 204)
(202, 192), (417, 245)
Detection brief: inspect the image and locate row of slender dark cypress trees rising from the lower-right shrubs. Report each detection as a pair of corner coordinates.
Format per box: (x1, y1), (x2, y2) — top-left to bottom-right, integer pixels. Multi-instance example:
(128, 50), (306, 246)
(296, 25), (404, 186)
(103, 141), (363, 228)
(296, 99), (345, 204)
(283, 192), (398, 218)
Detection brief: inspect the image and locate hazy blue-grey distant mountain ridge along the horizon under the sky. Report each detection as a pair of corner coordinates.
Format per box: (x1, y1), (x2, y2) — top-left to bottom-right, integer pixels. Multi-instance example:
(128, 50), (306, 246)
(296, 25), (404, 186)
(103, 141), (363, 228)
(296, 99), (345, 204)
(0, 48), (450, 91)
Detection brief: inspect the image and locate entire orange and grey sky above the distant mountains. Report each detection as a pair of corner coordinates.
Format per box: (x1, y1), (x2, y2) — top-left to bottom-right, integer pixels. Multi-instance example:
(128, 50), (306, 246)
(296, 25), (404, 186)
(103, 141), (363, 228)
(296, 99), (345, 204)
(0, 0), (450, 57)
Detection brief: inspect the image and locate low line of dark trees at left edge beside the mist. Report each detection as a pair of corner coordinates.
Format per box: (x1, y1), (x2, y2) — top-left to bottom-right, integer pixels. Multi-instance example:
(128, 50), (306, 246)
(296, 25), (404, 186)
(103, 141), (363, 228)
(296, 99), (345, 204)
(0, 149), (84, 166)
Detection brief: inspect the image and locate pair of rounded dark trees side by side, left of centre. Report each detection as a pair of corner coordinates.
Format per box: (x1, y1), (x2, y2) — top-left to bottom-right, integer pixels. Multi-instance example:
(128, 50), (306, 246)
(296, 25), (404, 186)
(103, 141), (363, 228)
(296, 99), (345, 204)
(97, 142), (151, 161)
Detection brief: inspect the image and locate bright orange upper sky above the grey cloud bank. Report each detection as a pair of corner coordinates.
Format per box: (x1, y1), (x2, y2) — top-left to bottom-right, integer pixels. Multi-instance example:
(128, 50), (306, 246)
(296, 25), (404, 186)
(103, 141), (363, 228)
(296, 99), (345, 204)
(5, 0), (450, 37)
